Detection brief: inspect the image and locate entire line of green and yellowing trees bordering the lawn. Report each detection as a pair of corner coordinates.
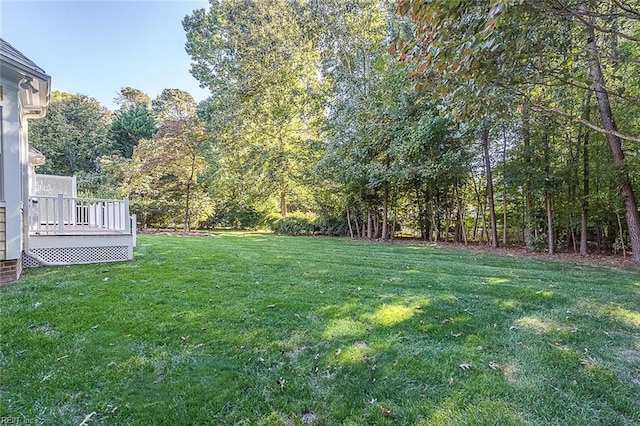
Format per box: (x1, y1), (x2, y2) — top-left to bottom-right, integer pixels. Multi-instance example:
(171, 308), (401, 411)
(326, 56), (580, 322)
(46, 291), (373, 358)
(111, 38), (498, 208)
(30, 0), (640, 260)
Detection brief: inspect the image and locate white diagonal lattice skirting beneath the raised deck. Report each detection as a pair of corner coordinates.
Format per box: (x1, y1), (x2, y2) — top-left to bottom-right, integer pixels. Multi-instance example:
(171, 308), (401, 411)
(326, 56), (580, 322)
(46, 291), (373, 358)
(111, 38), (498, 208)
(22, 246), (129, 268)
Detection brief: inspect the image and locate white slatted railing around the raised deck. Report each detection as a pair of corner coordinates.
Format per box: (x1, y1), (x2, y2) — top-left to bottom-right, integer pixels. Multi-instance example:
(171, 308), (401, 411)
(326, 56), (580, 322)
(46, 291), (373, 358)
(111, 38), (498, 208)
(29, 194), (135, 235)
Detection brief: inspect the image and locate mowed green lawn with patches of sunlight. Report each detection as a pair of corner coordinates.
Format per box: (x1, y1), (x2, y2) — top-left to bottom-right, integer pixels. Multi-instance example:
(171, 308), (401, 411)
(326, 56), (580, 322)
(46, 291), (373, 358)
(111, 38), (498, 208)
(0, 233), (640, 425)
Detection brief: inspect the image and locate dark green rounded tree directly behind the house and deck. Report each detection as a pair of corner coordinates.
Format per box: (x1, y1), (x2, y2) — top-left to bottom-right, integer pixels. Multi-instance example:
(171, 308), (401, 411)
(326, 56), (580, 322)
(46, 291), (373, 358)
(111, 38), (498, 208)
(29, 91), (110, 176)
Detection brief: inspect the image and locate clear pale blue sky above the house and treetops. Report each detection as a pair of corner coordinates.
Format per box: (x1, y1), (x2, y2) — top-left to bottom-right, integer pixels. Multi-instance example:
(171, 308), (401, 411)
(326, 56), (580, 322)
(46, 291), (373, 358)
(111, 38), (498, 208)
(0, 0), (209, 111)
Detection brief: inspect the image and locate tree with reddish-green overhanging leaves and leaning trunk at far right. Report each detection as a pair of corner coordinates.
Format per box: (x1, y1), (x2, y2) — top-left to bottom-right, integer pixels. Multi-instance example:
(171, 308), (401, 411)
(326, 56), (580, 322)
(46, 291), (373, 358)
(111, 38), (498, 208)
(397, 0), (640, 261)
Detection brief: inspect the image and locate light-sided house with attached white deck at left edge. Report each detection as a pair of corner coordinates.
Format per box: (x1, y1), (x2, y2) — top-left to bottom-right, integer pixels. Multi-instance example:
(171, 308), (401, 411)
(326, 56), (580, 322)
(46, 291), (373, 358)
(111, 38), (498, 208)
(0, 38), (136, 285)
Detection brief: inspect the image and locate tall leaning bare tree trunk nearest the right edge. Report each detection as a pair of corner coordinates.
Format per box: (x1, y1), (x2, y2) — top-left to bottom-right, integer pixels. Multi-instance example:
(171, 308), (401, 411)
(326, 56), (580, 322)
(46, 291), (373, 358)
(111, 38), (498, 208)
(583, 25), (640, 263)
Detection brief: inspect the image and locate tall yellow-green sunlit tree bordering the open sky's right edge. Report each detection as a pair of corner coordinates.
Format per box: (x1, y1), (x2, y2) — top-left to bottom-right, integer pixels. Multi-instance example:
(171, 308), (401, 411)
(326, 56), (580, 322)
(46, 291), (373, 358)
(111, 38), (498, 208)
(183, 0), (320, 216)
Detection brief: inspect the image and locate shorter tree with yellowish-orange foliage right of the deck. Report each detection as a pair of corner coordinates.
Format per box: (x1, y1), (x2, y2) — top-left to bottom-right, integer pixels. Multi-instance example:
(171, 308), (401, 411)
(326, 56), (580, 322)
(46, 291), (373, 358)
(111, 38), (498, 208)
(125, 89), (211, 232)
